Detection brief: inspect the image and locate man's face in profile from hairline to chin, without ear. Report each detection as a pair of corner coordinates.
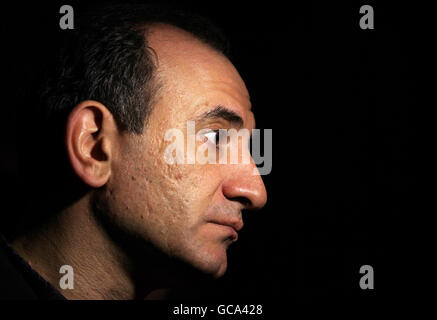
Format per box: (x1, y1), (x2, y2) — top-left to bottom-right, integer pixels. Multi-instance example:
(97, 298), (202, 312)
(106, 25), (267, 277)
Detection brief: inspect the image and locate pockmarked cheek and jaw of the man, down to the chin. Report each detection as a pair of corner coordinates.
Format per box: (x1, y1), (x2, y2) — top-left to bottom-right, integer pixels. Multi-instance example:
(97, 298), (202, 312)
(109, 121), (229, 276)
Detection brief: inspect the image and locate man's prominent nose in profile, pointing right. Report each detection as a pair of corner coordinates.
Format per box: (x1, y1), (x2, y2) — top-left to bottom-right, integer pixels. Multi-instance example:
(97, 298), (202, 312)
(222, 161), (267, 210)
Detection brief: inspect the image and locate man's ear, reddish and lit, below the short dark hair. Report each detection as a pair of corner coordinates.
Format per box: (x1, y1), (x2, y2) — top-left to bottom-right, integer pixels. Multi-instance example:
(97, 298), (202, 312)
(65, 100), (118, 188)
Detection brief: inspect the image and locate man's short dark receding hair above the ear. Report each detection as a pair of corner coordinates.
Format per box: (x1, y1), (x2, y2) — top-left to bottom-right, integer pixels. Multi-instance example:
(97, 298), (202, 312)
(42, 3), (229, 133)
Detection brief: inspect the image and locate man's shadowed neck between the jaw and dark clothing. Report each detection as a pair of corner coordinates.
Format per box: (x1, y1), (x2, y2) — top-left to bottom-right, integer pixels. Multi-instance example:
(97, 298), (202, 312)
(12, 195), (164, 299)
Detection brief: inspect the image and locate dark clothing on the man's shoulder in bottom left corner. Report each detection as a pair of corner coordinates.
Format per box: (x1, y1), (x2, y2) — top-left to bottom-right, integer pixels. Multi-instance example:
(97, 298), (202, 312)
(0, 235), (65, 300)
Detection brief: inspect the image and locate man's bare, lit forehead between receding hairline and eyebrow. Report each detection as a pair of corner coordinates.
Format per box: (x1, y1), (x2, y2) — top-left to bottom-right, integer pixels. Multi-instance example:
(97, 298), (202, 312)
(147, 24), (253, 122)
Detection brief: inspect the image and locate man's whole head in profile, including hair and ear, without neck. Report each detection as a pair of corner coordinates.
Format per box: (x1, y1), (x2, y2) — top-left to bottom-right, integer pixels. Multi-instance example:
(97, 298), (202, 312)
(42, 5), (266, 277)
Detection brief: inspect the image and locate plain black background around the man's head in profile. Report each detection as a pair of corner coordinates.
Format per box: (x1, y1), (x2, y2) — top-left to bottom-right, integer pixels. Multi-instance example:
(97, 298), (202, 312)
(0, 1), (418, 301)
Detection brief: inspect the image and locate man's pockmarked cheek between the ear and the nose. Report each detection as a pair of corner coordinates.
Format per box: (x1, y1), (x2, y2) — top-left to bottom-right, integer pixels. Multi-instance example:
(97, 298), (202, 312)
(113, 135), (225, 238)
